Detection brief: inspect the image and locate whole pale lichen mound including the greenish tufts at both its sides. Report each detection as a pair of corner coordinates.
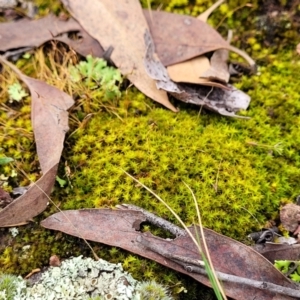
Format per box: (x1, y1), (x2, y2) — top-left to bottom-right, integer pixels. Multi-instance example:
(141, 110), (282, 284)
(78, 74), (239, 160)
(0, 256), (172, 300)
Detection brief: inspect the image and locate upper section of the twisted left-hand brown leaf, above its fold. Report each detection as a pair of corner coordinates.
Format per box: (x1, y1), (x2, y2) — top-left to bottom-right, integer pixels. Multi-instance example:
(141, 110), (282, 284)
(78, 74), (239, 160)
(20, 75), (74, 174)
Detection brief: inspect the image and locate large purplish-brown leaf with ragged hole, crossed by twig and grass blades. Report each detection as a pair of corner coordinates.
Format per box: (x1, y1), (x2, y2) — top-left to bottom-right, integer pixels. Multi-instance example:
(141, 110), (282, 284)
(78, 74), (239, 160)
(41, 209), (297, 300)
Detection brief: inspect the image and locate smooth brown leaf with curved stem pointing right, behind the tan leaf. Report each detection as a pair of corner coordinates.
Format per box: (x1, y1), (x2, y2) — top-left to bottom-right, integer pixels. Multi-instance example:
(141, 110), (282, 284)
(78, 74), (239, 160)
(144, 10), (255, 68)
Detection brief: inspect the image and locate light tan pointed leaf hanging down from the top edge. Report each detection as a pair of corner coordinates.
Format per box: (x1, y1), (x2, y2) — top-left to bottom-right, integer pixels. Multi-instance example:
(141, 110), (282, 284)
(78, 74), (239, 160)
(62, 0), (177, 111)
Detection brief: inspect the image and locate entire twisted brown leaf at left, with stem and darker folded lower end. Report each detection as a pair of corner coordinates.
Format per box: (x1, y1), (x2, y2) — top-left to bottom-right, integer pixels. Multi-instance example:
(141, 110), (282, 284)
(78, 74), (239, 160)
(0, 56), (74, 227)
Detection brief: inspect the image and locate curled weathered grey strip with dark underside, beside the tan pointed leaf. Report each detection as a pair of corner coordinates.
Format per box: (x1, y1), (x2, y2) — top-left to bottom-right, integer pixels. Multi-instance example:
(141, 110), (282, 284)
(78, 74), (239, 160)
(144, 31), (250, 118)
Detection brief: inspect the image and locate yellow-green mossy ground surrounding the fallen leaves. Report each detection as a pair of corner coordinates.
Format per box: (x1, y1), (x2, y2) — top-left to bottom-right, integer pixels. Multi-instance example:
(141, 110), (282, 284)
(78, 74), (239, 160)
(0, 1), (300, 299)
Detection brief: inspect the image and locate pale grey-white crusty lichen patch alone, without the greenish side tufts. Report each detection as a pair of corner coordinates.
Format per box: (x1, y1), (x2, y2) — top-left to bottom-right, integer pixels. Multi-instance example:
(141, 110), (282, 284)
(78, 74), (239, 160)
(20, 256), (137, 300)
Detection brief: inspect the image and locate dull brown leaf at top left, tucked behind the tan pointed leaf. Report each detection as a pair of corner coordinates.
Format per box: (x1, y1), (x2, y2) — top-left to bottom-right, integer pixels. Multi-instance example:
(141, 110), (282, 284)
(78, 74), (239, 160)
(0, 15), (104, 57)
